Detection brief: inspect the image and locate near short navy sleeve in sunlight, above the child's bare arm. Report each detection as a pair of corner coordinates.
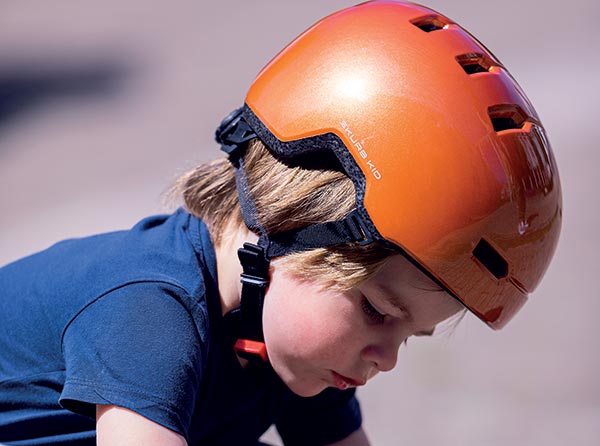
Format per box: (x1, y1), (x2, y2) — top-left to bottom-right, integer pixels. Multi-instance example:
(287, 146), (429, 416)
(60, 282), (204, 438)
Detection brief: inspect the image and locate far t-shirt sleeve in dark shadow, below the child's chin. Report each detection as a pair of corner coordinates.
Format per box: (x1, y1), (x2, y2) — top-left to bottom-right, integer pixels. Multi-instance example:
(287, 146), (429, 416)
(276, 388), (362, 446)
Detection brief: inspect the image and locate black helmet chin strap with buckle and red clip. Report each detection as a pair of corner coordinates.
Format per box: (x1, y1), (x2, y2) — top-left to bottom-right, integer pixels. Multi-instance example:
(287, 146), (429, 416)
(215, 108), (372, 362)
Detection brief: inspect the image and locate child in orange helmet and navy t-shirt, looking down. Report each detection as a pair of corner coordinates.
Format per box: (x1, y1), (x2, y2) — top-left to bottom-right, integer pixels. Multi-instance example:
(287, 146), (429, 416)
(0, 1), (562, 445)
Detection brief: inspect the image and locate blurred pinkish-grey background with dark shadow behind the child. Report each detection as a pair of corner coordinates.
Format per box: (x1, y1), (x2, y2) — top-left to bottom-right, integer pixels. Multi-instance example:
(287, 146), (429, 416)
(0, 0), (600, 446)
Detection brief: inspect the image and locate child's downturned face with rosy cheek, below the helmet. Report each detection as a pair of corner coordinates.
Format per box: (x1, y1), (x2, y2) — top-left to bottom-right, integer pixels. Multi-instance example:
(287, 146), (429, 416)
(263, 255), (463, 396)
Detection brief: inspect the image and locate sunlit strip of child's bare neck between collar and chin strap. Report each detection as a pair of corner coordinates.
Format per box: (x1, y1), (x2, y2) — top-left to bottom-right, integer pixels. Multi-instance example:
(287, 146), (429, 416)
(215, 225), (258, 315)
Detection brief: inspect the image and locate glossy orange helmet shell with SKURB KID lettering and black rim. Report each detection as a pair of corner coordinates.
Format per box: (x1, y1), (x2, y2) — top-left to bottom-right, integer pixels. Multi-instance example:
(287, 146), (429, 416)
(227, 1), (562, 329)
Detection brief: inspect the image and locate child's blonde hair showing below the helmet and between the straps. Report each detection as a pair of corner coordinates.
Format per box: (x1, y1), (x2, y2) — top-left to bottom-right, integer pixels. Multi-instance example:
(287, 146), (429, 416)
(171, 139), (395, 291)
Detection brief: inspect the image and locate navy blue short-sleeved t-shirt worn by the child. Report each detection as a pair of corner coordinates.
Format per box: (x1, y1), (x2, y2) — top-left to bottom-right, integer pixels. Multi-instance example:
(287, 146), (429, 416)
(0, 210), (361, 445)
